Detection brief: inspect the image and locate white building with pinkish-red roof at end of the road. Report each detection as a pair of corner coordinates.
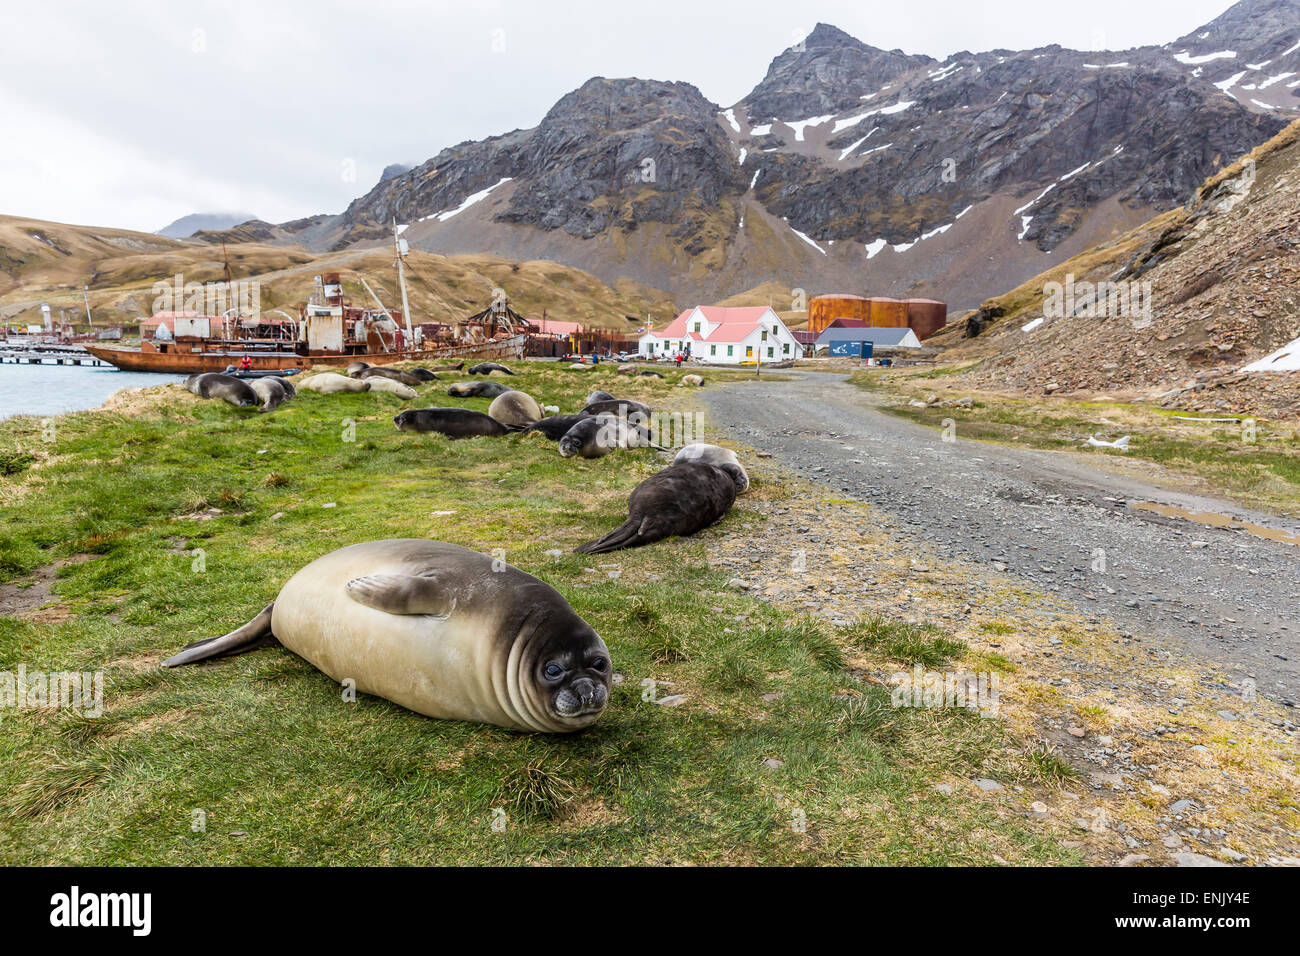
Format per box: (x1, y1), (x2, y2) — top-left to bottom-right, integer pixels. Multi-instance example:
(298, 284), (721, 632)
(637, 306), (803, 365)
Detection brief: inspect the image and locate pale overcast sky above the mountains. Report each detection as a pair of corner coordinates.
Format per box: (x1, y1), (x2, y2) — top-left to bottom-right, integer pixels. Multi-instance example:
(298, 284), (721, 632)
(0, 0), (1231, 232)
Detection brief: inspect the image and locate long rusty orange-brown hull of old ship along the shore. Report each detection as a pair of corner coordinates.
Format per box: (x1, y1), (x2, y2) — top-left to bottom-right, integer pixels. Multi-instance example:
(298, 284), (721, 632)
(83, 336), (527, 375)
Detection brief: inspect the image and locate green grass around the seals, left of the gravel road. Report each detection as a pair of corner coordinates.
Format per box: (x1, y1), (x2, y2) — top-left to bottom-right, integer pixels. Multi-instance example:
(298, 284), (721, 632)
(0, 364), (1075, 865)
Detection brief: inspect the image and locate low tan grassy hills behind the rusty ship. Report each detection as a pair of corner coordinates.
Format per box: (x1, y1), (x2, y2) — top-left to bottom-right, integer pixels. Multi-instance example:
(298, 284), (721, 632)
(0, 217), (676, 332)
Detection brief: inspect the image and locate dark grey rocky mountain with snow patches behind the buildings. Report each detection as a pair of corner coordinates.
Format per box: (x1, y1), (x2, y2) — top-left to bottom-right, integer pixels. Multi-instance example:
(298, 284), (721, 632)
(285, 0), (1300, 308)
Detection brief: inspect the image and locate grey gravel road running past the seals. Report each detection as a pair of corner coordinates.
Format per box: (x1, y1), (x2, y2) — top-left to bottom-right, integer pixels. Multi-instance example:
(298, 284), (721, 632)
(702, 372), (1300, 706)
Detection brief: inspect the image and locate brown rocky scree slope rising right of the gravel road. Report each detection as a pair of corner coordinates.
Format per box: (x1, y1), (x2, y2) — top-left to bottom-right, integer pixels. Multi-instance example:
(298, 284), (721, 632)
(931, 121), (1300, 416)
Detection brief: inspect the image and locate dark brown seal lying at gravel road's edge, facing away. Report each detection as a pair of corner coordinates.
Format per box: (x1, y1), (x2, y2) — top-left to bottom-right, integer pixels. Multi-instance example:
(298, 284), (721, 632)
(573, 462), (736, 554)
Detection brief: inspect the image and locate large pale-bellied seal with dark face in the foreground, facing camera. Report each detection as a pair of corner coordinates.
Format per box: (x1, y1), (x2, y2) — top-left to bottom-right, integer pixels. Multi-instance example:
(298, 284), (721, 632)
(163, 538), (614, 734)
